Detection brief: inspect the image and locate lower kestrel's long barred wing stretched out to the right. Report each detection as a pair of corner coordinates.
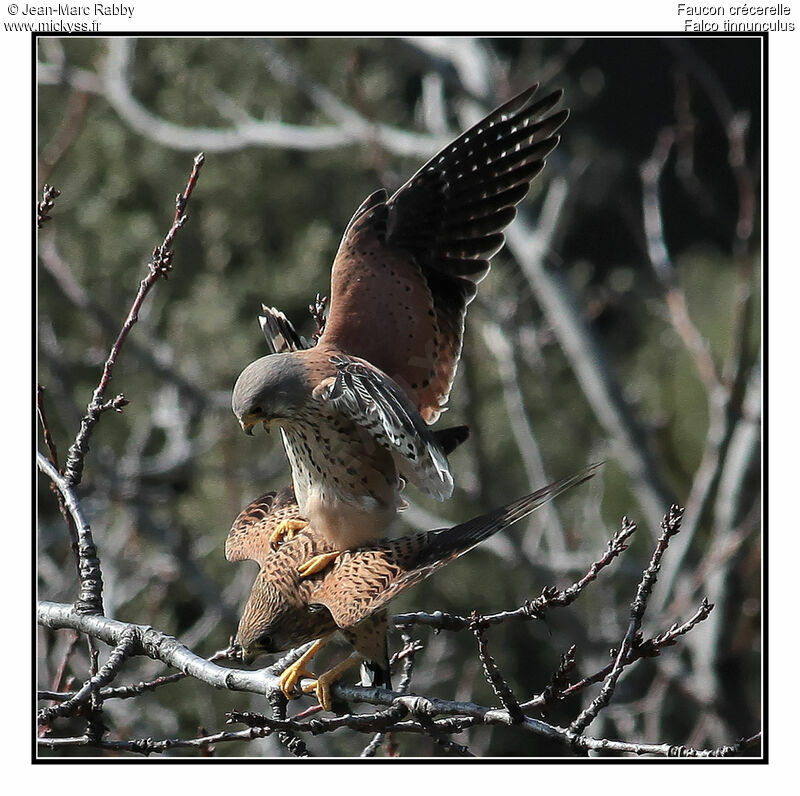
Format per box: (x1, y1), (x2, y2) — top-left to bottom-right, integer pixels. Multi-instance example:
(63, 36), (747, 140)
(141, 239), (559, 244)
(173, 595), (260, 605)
(308, 464), (600, 627)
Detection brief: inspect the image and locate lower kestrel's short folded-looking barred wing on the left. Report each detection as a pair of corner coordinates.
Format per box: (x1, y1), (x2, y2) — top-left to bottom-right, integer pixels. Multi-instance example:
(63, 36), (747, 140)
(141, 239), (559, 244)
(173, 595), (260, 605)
(225, 486), (303, 564)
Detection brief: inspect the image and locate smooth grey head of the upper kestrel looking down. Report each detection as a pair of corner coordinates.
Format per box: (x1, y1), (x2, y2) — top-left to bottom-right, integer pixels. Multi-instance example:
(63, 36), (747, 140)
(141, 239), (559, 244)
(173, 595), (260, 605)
(231, 353), (311, 434)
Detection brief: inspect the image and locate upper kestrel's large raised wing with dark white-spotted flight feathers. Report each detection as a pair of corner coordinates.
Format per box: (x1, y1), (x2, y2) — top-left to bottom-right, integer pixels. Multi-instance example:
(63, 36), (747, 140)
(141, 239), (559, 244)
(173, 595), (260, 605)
(321, 86), (568, 423)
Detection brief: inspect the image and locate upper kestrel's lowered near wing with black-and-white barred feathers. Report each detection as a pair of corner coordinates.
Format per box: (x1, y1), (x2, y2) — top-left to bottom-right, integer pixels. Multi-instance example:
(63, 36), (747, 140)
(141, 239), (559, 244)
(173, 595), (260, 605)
(314, 356), (457, 500)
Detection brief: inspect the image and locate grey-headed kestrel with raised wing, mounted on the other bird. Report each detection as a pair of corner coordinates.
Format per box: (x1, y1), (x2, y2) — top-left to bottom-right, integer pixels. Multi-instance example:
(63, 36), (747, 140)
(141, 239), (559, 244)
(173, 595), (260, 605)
(232, 85), (568, 575)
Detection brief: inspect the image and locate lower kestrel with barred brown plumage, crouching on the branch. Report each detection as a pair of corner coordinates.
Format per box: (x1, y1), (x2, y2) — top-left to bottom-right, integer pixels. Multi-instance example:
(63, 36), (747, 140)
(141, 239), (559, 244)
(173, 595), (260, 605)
(225, 464), (599, 710)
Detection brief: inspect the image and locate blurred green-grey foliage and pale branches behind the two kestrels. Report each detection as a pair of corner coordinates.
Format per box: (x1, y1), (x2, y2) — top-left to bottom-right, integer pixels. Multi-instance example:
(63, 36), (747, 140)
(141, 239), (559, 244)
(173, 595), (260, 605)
(37, 37), (762, 756)
